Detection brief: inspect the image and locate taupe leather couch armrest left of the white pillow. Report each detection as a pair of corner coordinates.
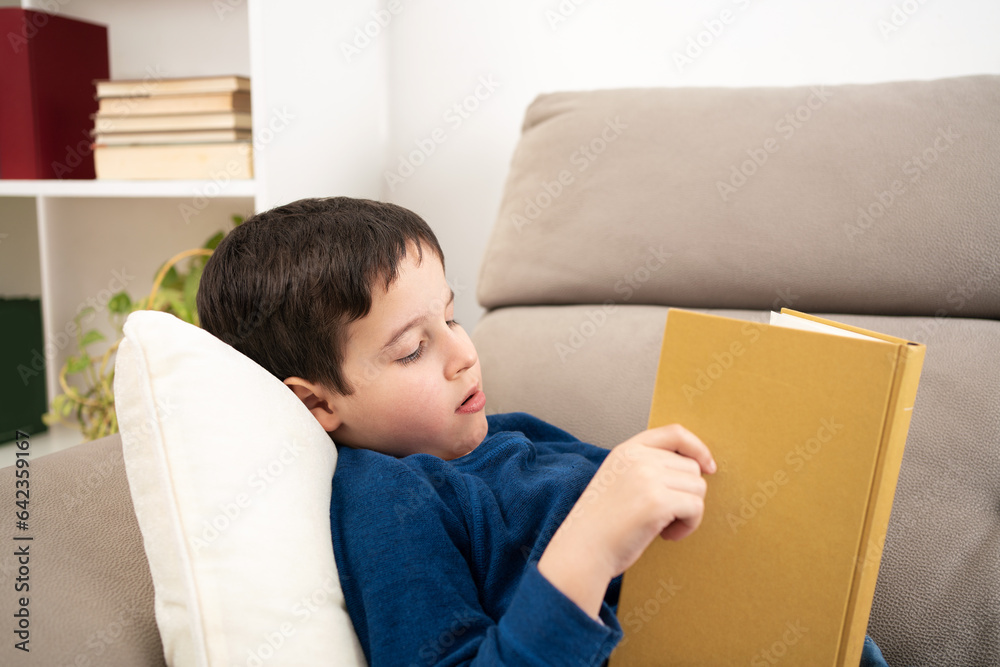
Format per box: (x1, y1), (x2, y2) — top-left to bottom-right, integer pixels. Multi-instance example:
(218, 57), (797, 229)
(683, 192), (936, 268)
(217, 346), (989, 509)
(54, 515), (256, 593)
(0, 435), (166, 667)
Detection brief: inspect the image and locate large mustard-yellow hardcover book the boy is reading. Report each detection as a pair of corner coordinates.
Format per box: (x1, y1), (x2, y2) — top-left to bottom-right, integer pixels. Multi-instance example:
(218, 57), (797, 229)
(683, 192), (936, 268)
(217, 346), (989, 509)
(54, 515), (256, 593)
(610, 308), (925, 667)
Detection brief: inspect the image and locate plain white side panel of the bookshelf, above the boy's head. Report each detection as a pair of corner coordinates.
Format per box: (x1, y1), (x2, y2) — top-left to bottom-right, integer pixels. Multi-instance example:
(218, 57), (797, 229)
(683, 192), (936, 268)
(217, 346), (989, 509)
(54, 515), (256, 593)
(250, 0), (391, 211)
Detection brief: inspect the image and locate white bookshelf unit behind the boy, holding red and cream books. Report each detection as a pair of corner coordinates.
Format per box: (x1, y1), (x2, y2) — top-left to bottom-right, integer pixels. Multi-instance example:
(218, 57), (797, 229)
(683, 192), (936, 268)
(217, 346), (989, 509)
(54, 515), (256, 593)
(0, 0), (388, 444)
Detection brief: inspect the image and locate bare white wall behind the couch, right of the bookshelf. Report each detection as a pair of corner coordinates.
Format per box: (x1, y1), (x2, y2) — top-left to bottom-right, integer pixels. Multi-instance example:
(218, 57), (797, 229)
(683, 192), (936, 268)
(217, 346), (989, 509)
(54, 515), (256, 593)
(378, 0), (1000, 330)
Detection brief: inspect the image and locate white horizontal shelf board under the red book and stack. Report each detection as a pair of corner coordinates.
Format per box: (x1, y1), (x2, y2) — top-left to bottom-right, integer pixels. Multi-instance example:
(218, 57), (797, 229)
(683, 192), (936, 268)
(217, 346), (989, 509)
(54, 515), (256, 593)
(0, 179), (257, 198)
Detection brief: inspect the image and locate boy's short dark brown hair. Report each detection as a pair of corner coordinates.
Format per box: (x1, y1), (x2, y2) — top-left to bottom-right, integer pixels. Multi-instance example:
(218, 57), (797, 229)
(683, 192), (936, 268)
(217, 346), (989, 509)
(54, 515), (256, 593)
(197, 197), (444, 395)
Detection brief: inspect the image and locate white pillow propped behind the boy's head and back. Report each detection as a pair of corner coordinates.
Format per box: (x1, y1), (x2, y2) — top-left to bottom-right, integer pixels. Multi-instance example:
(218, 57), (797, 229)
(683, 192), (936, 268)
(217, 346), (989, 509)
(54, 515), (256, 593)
(114, 311), (365, 667)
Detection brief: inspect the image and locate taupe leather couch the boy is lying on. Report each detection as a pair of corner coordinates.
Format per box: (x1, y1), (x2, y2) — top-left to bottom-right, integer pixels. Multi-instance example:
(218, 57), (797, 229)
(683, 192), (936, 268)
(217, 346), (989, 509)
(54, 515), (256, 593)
(0, 76), (1000, 667)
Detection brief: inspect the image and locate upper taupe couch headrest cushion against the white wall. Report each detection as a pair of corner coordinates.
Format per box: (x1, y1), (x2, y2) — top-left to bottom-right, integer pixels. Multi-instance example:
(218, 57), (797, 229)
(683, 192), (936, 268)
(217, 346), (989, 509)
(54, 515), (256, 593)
(478, 76), (1000, 318)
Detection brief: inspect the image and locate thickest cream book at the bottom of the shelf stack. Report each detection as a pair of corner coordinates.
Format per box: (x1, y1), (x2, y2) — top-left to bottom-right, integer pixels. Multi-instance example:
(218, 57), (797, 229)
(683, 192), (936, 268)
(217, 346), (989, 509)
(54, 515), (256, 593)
(94, 142), (253, 180)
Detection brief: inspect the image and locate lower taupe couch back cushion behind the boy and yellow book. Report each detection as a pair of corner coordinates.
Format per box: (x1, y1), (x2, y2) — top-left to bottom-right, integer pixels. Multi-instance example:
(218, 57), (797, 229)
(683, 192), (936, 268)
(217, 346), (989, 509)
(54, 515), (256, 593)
(473, 305), (1000, 666)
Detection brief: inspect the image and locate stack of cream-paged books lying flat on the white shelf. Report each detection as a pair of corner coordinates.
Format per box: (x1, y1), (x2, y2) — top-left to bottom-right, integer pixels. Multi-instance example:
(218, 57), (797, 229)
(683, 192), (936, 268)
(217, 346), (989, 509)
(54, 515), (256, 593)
(92, 76), (253, 181)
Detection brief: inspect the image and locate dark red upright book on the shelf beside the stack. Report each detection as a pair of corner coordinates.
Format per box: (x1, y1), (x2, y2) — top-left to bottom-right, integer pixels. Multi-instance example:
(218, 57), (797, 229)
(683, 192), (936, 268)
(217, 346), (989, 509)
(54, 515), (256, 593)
(0, 7), (108, 179)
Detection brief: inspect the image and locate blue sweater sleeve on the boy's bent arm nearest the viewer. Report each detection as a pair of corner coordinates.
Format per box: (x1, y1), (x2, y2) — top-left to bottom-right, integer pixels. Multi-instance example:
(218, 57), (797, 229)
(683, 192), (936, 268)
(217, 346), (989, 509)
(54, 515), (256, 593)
(334, 460), (622, 667)
